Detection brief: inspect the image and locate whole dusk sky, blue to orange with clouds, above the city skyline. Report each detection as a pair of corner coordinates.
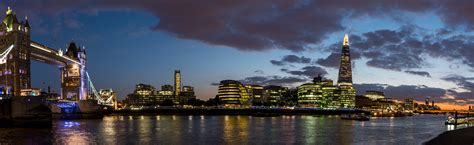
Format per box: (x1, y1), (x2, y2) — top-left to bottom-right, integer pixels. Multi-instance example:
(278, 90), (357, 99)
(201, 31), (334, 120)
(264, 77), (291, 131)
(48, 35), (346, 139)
(0, 0), (474, 109)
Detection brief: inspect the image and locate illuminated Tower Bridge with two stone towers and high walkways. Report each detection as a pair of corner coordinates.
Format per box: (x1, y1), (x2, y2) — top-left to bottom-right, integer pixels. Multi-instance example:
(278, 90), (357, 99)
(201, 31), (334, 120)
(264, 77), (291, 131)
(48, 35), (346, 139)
(0, 8), (115, 106)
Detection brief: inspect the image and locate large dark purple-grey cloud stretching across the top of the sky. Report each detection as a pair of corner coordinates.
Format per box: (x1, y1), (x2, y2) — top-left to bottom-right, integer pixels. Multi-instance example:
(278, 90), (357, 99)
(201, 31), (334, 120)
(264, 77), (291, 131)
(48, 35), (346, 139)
(8, 0), (474, 52)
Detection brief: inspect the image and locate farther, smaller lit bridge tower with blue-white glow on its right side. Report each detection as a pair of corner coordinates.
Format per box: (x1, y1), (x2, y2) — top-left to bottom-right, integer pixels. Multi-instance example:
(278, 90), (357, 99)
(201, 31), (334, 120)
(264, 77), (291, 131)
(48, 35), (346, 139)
(60, 42), (87, 101)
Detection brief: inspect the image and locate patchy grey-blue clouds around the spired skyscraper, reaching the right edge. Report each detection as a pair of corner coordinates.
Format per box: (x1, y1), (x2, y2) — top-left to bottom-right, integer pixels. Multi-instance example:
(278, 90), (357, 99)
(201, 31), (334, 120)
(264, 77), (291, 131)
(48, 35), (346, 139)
(336, 25), (474, 74)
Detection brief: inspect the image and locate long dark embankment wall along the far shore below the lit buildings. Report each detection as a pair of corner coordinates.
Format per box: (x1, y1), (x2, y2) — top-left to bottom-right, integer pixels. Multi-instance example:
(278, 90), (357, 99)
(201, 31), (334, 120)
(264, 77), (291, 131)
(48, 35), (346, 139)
(110, 108), (370, 115)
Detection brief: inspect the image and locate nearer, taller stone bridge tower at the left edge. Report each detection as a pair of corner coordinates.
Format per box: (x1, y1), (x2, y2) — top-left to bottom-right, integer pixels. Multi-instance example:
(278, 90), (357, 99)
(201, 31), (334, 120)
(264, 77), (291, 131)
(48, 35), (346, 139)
(0, 8), (31, 96)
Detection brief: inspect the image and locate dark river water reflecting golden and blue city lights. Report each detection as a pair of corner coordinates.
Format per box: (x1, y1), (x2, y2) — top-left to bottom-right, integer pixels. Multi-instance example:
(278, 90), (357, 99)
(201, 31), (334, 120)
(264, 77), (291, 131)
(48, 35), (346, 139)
(0, 115), (448, 145)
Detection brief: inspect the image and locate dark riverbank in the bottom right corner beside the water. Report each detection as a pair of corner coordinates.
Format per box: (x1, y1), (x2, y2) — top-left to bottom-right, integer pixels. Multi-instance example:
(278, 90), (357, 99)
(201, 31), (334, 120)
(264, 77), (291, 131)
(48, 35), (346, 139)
(424, 127), (474, 145)
